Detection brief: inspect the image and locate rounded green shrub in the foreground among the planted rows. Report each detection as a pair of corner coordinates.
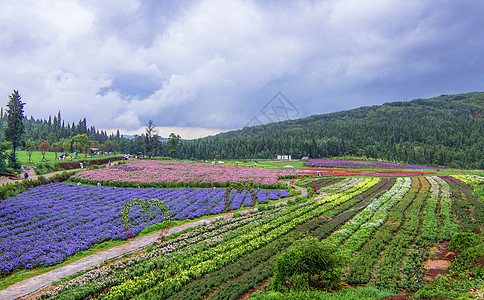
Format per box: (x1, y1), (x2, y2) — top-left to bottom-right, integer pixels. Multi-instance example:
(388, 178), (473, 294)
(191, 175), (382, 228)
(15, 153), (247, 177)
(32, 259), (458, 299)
(272, 237), (342, 292)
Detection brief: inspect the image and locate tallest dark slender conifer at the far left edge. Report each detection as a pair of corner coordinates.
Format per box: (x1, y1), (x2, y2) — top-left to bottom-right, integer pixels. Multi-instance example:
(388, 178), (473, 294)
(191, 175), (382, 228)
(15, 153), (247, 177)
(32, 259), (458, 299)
(5, 90), (25, 169)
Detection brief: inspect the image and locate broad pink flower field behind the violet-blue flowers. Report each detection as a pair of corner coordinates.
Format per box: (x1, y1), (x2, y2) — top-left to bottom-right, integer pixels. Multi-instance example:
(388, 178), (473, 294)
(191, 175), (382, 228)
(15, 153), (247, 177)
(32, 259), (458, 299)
(73, 160), (291, 186)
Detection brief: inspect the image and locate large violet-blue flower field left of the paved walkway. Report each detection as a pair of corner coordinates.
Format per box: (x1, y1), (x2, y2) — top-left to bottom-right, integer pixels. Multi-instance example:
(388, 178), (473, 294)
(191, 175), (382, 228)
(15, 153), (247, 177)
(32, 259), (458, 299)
(0, 183), (289, 274)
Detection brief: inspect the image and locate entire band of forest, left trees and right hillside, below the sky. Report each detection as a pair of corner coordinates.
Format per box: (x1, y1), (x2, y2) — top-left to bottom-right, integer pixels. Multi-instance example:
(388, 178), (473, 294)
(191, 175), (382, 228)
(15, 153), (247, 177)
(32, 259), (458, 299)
(0, 91), (484, 171)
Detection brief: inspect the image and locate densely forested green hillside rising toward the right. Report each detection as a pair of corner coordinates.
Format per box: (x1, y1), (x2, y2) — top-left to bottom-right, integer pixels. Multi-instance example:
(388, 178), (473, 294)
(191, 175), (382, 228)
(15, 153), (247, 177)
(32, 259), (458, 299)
(179, 93), (484, 169)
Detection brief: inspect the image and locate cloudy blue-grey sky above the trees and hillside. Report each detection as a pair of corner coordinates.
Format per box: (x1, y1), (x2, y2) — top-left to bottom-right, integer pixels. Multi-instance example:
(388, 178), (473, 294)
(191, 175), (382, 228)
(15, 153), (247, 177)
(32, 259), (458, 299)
(0, 0), (484, 139)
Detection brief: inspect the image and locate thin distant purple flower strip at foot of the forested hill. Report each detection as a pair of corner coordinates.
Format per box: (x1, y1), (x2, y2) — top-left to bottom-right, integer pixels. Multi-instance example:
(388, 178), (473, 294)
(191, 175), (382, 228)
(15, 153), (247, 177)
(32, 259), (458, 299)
(304, 159), (435, 170)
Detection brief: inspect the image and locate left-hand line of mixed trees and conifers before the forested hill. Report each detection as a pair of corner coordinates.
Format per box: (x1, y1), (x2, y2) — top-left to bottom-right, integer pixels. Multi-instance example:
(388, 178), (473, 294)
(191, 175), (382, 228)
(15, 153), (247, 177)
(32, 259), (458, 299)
(0, 90), (181, 174)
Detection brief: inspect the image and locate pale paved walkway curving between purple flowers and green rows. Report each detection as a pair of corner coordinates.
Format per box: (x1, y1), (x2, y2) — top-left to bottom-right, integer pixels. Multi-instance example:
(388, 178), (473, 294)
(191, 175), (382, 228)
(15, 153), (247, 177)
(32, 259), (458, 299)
(0, 187), (307, 300)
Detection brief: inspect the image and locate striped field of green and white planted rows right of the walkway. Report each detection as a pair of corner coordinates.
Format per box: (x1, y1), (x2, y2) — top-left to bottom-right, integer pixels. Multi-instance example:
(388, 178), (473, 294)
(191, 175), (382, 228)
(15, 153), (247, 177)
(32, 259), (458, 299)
(26, 176), (484, 299)
